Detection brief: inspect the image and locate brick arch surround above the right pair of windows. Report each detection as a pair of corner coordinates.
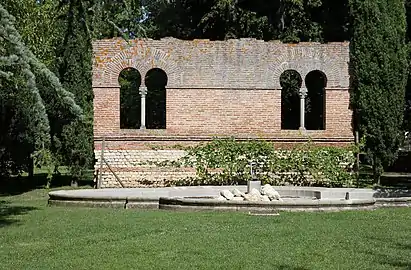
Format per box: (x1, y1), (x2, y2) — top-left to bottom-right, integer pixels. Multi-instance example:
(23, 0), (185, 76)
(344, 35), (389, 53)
(269, 50), (346, 89)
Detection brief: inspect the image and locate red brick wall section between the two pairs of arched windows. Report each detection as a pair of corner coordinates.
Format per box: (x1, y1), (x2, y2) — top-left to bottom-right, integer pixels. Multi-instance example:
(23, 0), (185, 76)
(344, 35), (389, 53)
(167, 89), (281, 135)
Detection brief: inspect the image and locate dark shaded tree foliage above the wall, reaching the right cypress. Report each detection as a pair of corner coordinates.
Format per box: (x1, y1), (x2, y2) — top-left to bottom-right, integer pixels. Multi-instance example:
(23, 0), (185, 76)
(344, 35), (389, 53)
(147, 0), (348, 42)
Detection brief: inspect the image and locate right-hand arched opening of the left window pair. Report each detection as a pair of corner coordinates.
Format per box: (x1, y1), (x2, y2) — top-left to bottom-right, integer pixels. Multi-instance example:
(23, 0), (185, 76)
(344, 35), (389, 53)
(145, 68), (167, 129)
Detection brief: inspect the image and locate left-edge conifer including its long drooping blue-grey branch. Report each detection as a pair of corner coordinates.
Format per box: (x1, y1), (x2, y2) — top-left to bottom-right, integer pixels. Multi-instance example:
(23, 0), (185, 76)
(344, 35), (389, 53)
(0, 5), (82, 175)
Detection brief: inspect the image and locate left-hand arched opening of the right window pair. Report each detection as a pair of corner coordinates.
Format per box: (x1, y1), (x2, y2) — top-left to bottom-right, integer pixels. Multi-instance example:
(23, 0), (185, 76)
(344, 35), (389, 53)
(280, 70), (303, 130)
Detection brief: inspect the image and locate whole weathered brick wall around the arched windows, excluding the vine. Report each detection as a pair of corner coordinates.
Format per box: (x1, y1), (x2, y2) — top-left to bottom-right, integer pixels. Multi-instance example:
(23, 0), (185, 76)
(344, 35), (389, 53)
(93, 38), (353, 187)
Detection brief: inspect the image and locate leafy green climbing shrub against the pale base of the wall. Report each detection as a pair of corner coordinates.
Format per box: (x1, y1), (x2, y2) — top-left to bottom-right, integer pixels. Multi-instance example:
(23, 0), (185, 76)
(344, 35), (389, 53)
(158, 139), (355, 187)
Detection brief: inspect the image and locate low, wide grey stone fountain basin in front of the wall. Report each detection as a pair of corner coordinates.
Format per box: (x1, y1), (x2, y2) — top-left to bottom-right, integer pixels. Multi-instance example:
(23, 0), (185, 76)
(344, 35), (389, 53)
(49, 186), (400, 213)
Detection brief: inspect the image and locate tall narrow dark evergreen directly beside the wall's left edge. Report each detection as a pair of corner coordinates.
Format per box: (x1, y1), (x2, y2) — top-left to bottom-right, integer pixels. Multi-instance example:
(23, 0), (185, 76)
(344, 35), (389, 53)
(57, 0), (94, 184)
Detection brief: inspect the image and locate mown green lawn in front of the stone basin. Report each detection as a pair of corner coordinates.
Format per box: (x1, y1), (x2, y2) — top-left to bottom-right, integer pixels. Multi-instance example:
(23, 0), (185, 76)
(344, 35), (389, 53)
(0, 190), (411, 270)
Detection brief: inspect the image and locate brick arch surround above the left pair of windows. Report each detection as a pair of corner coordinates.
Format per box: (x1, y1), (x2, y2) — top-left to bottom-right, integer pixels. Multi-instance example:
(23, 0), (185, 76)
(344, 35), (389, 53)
(103, 46), (179, 87)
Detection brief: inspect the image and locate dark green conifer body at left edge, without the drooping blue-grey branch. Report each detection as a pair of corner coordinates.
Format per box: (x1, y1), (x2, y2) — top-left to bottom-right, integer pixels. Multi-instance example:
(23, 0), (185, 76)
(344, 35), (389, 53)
(0, 5), (49, 174)
